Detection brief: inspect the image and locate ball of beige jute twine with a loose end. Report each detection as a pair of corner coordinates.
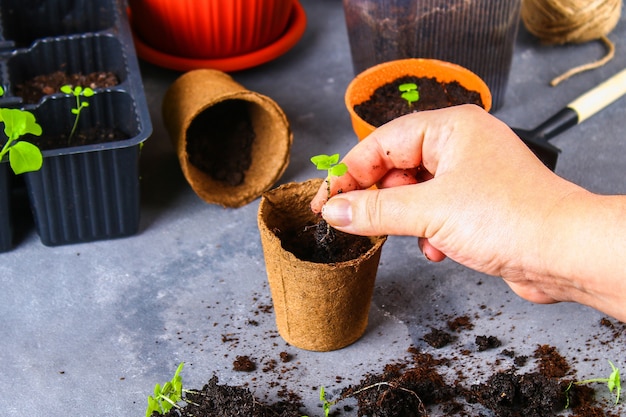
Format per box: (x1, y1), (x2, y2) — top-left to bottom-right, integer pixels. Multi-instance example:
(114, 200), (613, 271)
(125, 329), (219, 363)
(521, 0), (622, 86)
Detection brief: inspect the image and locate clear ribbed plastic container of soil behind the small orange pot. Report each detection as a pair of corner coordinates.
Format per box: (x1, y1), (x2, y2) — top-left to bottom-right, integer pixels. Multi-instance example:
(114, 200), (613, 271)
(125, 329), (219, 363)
(343, 0), (521, 111)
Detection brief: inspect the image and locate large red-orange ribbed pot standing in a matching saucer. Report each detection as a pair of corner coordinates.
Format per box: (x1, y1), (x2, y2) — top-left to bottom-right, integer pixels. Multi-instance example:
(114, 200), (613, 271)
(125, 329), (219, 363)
(129, 0), (294, 59)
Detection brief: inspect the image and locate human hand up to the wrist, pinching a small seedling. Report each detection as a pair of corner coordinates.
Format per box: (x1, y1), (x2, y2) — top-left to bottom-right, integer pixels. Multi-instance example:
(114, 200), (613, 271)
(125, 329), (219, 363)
(311, 106), (590, 303)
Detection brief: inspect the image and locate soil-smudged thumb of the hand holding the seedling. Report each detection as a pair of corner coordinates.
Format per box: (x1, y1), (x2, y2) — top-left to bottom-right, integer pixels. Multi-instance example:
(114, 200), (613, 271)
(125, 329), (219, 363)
(322, 182), (428, 237)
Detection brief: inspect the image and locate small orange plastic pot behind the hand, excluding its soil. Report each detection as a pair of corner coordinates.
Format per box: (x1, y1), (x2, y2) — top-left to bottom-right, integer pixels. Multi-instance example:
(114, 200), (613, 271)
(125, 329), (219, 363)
(345, 58), (491, 140)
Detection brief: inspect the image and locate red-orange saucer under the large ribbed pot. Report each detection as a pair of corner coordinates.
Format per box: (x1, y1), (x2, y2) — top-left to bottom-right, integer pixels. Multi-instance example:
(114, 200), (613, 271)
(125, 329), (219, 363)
(128, 1), (306, 72)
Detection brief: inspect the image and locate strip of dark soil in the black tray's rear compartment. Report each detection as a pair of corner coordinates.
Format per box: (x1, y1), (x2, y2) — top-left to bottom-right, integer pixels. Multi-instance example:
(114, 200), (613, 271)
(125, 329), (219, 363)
(15, 71), (119, 104)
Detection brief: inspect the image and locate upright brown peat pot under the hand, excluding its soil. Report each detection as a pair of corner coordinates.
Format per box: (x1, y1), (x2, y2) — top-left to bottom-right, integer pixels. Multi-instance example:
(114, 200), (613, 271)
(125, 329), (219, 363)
(258, 180), (386, 351)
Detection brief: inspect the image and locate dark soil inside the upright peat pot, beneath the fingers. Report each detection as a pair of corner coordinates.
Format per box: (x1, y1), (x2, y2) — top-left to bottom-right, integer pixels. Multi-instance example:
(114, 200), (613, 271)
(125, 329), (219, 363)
(279, 220), (374, 263)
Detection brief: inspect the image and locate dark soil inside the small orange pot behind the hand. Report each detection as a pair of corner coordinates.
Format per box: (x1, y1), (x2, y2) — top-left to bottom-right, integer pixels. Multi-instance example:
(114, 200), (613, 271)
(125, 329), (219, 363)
(354, 75), (485, 127)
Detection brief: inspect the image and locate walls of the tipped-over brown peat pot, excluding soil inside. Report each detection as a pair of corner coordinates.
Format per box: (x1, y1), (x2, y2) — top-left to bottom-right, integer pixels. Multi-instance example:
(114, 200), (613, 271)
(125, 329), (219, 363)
(163, 69), (293, 207)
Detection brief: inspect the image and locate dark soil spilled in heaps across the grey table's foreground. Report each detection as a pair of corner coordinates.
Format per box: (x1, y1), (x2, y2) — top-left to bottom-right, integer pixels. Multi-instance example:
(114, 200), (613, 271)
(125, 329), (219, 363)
(153, 316), (626, 417)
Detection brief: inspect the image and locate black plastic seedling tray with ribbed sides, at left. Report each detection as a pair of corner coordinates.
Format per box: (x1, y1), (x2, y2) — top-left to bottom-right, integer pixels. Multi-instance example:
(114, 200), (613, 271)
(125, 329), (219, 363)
(0, 0), (152, 251)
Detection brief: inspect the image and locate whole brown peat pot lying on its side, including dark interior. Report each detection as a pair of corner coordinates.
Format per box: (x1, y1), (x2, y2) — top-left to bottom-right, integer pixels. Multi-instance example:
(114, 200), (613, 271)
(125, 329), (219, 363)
(163, 69), (293, 208)
